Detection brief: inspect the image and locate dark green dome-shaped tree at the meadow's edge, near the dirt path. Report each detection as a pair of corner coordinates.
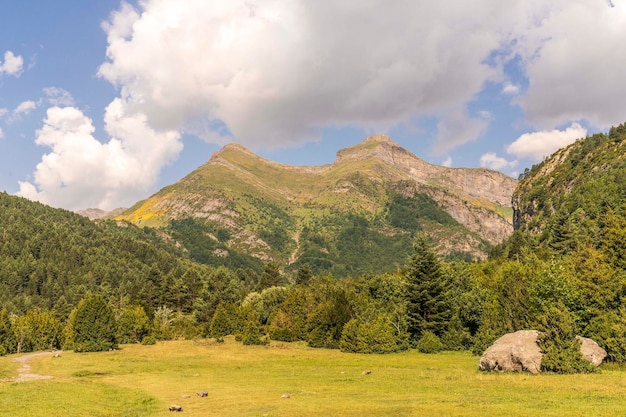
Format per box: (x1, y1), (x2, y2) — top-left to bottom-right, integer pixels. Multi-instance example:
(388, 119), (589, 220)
(72, 295), (117, 352)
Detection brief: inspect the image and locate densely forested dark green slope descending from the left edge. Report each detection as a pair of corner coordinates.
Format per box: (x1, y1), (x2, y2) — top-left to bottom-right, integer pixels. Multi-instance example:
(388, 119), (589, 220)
(0, 193), (208, 314)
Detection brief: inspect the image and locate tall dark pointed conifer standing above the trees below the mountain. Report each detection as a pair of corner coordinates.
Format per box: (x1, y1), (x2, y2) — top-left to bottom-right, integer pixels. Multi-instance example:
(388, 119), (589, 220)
(407, 233), (451, 340)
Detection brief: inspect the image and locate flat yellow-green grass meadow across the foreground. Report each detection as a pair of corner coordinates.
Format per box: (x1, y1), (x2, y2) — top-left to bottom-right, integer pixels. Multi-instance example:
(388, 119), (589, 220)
(0, 339), (626, 417)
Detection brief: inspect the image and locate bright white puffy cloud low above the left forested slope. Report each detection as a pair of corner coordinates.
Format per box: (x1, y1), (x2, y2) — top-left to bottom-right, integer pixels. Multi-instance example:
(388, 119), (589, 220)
(18, 100), (182, 210)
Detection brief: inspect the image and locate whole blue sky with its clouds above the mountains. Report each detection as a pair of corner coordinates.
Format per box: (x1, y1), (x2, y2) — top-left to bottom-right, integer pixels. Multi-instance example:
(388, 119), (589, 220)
(0, 0), (626, 210)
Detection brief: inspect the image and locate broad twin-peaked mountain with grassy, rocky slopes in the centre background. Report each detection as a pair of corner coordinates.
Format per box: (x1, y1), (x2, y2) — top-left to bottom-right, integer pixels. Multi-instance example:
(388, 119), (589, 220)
(117, 135), (517, 275)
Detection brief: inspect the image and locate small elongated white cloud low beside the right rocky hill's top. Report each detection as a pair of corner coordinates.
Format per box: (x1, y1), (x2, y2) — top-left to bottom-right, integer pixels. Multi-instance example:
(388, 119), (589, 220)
(506, 123), (587, 159)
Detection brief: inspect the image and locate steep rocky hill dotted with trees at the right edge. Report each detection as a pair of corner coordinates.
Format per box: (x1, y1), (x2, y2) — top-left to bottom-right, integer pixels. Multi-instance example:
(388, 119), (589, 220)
(513, 124), (626, 253)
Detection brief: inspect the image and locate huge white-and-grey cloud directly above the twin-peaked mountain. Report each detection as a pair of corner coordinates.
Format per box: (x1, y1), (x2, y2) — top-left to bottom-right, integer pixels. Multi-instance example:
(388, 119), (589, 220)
(99, 0), (514, 152)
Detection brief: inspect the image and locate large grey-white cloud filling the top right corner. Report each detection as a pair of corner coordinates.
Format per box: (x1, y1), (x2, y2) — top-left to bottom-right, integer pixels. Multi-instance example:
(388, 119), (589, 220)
(516, 0), (626, 129)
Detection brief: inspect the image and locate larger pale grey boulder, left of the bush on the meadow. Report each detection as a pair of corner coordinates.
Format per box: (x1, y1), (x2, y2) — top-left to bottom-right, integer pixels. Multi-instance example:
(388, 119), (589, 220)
(478, 330), (541, 374)
